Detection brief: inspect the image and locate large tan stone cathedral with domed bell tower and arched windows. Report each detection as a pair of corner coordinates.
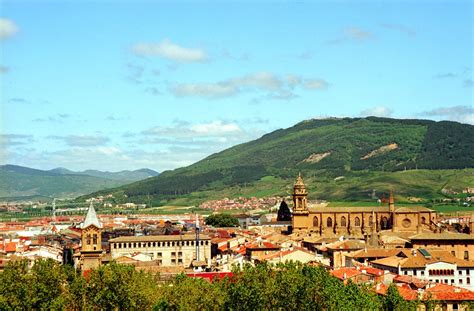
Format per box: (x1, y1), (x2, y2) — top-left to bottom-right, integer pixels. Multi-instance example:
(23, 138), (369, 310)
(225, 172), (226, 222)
(292, 175), (436, 237)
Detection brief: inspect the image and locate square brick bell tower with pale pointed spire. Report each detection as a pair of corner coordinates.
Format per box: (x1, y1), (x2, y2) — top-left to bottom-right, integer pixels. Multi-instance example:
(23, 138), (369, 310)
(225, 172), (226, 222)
(80, 202), (103, 271)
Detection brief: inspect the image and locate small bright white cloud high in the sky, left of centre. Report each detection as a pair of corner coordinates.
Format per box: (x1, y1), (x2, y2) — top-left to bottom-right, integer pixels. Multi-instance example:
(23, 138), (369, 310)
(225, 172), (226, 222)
(132, 39), (207, 63)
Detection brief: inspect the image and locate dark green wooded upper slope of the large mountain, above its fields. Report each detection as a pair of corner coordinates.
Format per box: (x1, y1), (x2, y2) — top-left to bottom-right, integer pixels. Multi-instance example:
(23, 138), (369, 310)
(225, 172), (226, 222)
(84, 117), (474, 205)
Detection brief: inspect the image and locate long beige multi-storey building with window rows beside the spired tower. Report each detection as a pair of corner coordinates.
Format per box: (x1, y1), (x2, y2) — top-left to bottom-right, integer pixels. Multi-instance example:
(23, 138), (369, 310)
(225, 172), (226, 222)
(109, 234), (211, 267)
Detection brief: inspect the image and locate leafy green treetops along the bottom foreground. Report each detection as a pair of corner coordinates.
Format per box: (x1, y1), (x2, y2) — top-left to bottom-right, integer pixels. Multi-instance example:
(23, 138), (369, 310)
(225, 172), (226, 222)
(0, 260), (440, 311)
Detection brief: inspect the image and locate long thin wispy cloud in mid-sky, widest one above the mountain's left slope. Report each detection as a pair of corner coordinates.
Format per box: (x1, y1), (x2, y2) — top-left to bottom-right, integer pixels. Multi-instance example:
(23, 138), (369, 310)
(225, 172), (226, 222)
(170, 72), (328, 99)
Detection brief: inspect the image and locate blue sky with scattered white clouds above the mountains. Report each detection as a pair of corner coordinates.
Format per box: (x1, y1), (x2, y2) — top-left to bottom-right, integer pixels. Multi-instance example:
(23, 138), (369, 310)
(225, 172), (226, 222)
(0, 0), (474, 171)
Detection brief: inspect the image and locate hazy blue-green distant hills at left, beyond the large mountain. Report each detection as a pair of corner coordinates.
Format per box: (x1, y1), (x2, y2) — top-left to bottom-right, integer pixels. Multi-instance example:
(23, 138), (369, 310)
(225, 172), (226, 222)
(0, 165), (158, 200)
